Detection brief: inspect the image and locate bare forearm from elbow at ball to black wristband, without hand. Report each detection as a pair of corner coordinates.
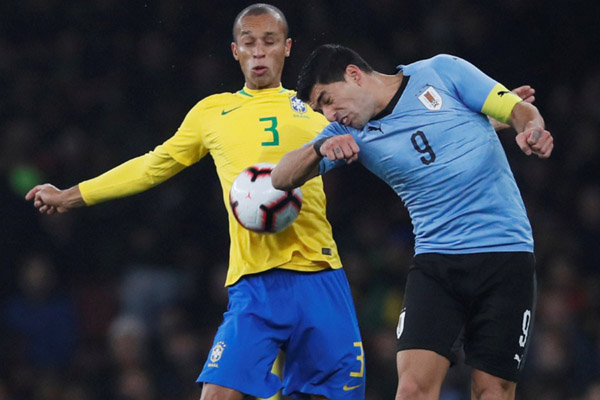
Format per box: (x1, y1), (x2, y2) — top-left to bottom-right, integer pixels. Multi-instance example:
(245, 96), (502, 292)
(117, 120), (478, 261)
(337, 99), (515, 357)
(271, 145), (321, 190)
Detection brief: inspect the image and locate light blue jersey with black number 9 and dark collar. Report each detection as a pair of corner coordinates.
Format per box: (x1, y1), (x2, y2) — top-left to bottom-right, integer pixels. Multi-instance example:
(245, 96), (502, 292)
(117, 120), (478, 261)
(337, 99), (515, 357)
(316, 55), (533, 254)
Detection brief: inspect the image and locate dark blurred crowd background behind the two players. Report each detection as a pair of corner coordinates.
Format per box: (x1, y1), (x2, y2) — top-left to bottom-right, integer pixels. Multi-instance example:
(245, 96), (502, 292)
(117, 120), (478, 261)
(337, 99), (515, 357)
(0, 0), (600, 400)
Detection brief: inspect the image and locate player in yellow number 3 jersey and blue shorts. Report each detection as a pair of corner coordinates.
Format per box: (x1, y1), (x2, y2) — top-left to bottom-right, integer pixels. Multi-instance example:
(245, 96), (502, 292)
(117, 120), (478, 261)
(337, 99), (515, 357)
(26, 4), (365, 400)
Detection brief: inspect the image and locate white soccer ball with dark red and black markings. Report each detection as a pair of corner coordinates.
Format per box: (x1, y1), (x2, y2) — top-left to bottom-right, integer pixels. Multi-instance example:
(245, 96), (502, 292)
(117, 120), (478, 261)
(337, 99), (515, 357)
(229, 163), (302, 233)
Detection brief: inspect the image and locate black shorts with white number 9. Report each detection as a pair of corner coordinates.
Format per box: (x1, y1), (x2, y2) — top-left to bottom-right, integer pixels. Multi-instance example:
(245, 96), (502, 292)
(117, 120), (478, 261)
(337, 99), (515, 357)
(397, 252), (536, 382)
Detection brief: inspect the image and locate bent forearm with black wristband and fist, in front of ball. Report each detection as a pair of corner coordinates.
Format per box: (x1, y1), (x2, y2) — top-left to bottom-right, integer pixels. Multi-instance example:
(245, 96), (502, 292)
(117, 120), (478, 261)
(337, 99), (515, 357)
(271, 134), (360, 190)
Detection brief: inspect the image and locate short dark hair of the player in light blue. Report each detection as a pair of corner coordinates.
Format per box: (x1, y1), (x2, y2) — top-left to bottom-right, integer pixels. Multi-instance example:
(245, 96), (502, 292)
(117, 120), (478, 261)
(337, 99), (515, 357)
(296, 44), (373, 102)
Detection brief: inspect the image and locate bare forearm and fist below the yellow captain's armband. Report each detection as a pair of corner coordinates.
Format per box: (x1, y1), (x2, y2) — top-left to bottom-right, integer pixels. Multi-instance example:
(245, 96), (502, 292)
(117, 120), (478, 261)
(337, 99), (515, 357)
(510, 101), (554, 158)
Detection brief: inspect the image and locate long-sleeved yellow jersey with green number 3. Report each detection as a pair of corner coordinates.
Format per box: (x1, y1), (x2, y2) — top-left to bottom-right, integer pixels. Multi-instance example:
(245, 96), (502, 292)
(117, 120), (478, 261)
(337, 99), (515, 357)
(79, 86), (342, 286)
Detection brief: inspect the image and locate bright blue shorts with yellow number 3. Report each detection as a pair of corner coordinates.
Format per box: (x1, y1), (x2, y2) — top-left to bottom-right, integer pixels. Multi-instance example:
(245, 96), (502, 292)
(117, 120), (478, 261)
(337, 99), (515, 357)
(198, 269), (365, 400)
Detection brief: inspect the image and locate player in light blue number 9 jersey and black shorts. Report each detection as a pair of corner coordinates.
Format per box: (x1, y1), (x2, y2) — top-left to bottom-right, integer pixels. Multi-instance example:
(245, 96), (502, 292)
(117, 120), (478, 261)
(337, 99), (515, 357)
(272, 45), (553, 400)
